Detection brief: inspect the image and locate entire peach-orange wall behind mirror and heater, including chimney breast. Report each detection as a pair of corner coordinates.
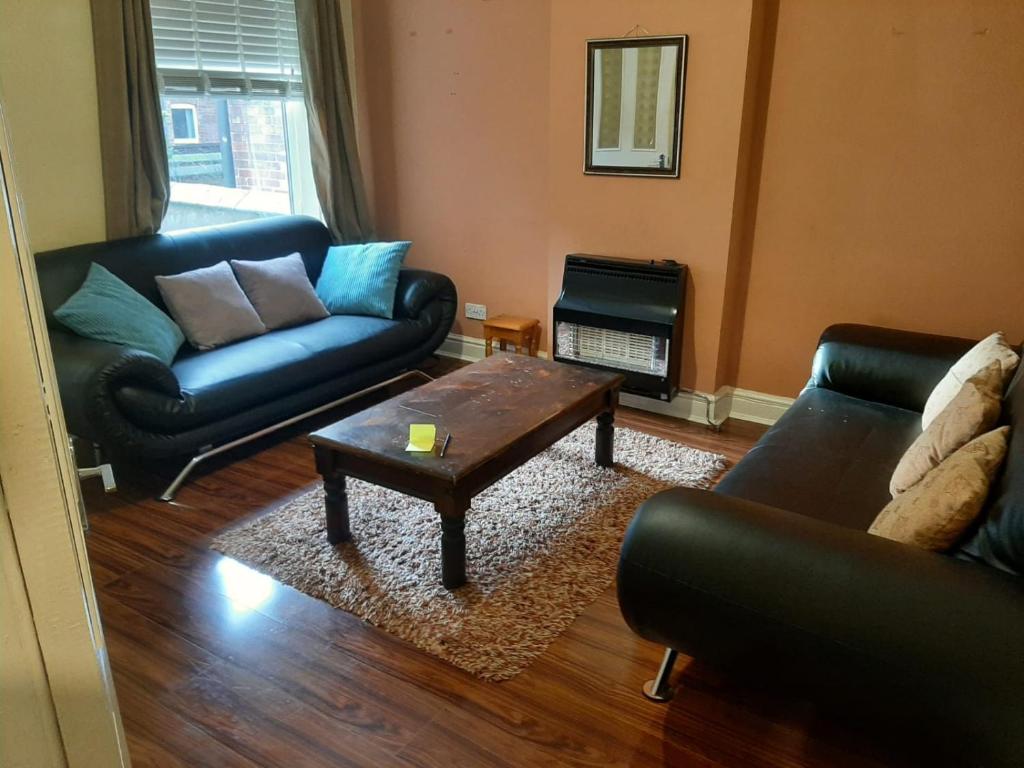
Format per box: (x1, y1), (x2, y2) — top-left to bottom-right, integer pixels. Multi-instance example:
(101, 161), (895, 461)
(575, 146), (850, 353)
(356, 0), (1024, 403)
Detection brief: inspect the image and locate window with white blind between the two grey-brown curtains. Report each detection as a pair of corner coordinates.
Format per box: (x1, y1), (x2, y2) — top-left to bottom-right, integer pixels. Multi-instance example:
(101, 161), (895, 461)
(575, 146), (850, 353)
(151, 0), (321, 231)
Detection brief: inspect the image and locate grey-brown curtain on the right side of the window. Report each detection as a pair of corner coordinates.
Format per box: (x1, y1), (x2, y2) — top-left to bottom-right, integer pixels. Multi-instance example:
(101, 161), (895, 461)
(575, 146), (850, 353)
(295, 0), (373, 243)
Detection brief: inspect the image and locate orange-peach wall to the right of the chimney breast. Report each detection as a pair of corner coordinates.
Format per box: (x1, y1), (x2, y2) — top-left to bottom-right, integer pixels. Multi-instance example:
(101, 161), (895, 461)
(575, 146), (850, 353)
(738, 0), (1024, 395)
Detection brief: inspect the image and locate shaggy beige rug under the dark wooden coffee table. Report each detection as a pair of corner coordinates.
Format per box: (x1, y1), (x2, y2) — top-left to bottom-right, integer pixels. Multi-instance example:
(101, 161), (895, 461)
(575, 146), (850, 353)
(212, 423), (725, 680)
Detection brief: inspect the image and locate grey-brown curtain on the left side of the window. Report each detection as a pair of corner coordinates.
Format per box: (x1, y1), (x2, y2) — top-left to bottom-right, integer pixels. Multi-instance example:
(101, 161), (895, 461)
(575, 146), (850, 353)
(92, 0), (171, 240)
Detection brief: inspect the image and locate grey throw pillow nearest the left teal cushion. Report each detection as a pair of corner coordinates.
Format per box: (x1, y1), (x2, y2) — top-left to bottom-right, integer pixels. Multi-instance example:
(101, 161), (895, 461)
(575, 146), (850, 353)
(157, 261), (266, 349)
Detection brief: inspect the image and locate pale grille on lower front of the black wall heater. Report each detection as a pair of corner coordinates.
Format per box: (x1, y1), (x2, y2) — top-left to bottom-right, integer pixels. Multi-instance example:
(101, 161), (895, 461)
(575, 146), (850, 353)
(555, 323), (669, 376)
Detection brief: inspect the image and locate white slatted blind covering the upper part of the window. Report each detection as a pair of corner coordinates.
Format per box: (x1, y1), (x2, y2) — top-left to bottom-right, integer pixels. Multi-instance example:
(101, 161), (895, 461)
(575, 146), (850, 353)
(150, 0), (302, 95)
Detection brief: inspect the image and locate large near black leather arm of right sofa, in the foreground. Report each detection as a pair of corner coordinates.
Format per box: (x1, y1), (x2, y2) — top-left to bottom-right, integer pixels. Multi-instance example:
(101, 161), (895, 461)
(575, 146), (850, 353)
(618, 488), (1024, 755)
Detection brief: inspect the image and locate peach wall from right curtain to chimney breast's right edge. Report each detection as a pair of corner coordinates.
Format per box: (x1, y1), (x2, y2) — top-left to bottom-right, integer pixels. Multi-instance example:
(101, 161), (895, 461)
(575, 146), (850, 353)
(354, 0), (752, 389)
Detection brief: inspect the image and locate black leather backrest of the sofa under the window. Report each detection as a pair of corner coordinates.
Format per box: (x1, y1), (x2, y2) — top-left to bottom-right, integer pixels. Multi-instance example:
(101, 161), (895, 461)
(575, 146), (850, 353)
(36, 216), (331, 325)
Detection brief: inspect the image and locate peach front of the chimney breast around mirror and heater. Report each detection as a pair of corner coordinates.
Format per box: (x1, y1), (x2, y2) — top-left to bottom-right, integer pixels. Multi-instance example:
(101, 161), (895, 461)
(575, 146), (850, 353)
(548, 0), (752, 391)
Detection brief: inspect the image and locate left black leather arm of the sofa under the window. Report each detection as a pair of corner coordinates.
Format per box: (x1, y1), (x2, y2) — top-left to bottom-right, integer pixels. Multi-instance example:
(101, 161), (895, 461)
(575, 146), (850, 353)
(50, 331), (181, 439)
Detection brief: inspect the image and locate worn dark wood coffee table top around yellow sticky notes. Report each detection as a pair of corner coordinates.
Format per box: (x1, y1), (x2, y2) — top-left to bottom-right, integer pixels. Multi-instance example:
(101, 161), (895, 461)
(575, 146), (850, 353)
(309, 355), (624, 484)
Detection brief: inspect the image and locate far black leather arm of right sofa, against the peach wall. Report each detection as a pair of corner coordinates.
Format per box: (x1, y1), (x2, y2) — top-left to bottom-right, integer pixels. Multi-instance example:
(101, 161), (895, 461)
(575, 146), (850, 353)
(808, 325), (976, 411)
